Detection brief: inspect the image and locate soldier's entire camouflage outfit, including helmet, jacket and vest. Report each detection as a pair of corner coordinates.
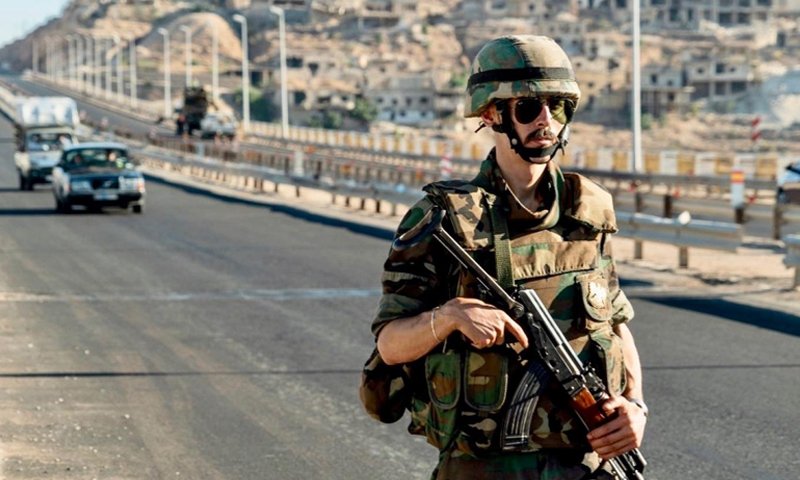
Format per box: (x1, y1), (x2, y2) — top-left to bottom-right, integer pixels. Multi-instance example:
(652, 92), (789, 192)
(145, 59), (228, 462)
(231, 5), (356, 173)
(362, 36), (633, 480)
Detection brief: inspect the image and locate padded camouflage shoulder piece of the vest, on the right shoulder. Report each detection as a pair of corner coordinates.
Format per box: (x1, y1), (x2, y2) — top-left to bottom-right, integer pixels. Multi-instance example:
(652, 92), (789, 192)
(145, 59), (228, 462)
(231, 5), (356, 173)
(563, 172), (619, 233)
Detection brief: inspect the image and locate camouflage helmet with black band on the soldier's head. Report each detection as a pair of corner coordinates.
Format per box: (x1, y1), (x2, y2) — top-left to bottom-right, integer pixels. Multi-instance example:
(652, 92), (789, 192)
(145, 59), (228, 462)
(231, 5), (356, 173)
(464, 35), (581, 117)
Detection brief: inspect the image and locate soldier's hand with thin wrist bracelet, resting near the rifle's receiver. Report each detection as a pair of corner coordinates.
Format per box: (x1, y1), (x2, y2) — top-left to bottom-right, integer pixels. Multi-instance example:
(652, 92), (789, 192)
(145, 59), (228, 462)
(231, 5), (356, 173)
(442, 297), (528, 348)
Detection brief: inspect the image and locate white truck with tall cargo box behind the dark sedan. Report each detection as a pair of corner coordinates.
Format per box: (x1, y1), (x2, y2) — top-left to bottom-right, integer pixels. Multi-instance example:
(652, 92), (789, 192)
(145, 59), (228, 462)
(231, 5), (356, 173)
(14, 97), (80, 190)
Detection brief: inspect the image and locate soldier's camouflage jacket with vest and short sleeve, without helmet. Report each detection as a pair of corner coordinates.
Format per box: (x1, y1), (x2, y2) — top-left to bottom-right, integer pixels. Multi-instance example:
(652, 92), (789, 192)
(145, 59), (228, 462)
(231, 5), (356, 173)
(372, 154), (633, 457)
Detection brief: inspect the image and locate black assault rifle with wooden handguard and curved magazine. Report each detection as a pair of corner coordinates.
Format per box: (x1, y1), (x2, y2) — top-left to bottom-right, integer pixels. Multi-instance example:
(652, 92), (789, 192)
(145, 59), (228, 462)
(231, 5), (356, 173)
(392, 208), (647, 480)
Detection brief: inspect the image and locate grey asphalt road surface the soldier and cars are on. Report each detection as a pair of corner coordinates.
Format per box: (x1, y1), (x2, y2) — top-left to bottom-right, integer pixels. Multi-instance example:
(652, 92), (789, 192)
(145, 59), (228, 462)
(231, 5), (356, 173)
(0, 80), (800, 480)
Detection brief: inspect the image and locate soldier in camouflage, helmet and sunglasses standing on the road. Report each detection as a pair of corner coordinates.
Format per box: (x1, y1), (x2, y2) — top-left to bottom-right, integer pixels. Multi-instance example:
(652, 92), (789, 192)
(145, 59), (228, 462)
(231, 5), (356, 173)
(372, 35), (647, 480)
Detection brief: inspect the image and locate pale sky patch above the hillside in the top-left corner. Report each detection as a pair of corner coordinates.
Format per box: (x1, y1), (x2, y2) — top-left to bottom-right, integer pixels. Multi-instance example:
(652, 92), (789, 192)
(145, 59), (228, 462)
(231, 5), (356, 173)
(0, 0), (69, 47)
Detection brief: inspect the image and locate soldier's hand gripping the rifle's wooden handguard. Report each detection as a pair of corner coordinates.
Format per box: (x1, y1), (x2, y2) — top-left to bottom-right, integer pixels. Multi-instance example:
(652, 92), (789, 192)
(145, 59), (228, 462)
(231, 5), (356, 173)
(586, 396), (647, 460)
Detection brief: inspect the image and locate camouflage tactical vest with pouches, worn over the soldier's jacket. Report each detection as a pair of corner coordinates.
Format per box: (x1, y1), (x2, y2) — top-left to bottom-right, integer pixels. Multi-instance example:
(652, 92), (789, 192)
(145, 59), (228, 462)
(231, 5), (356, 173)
(409, 174), (627, 457)
